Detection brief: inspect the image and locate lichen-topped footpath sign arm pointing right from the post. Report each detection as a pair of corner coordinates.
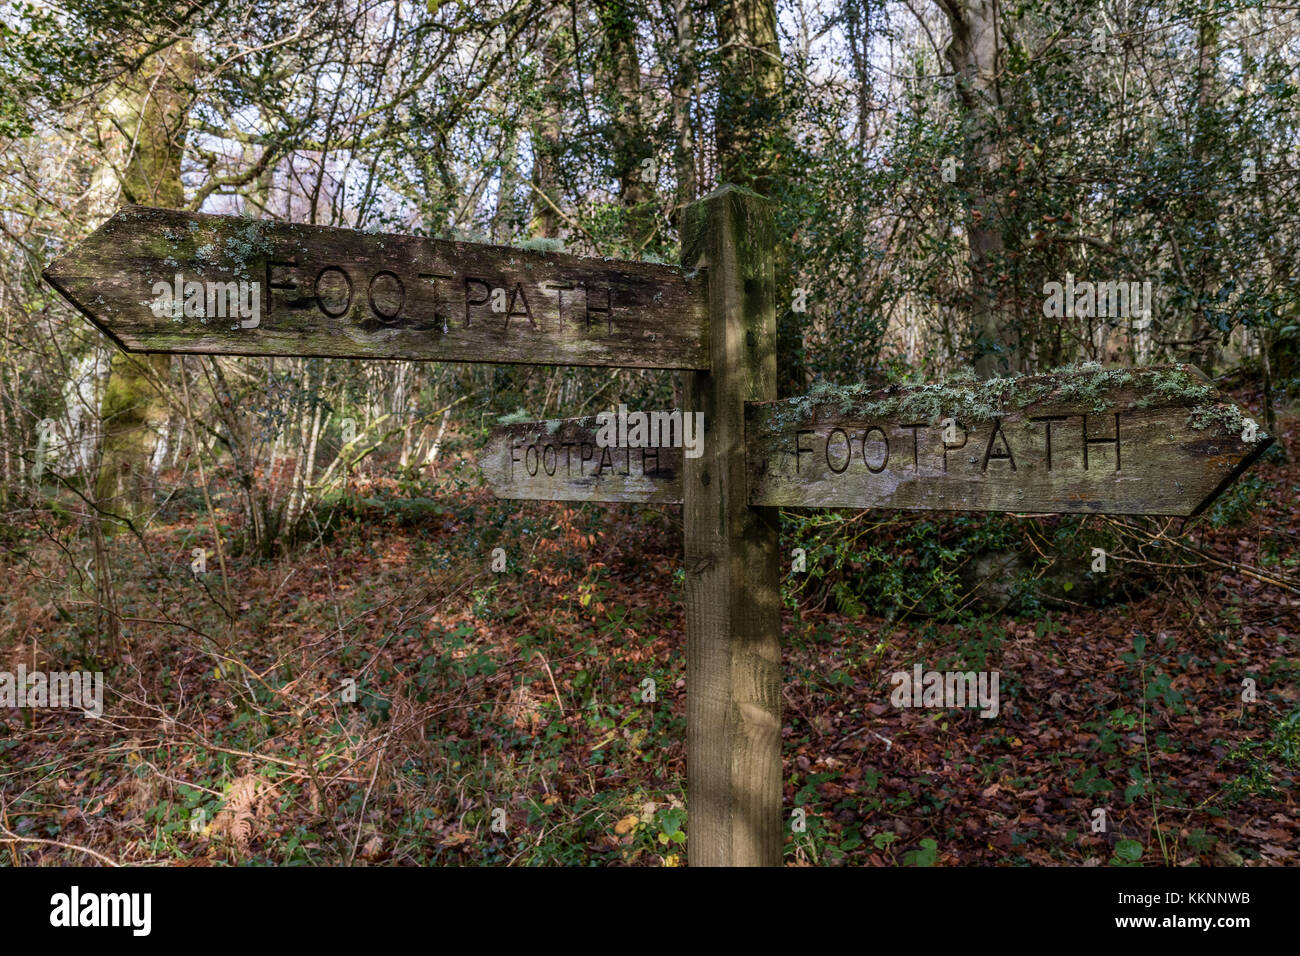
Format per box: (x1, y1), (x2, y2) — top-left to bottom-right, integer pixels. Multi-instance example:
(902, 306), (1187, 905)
(748, 365), (1273, 516)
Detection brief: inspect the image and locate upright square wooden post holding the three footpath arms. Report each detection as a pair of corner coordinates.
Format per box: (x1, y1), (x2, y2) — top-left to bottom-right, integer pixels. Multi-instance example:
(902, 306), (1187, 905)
(683, 186), (783, 866)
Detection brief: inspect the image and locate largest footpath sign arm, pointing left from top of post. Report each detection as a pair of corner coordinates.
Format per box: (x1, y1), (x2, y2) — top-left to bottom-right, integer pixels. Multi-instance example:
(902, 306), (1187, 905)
(44, 206), (709, 368)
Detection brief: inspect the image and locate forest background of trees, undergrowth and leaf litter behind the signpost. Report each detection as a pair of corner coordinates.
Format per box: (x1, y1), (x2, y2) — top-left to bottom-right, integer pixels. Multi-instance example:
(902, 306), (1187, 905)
(0, 0), (1300, 865)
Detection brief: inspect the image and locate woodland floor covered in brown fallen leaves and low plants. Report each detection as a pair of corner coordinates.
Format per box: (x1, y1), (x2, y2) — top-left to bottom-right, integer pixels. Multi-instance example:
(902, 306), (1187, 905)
(0, 397), (1300, 866)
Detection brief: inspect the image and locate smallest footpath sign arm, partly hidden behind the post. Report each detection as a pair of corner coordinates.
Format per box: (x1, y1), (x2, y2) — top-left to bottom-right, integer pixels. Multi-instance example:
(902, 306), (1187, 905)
(478, 416), (683, 505)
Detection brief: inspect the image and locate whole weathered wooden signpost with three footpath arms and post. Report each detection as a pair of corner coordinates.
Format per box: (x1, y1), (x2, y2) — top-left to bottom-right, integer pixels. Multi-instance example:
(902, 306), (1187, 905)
(44, 186), (1273, 865)
